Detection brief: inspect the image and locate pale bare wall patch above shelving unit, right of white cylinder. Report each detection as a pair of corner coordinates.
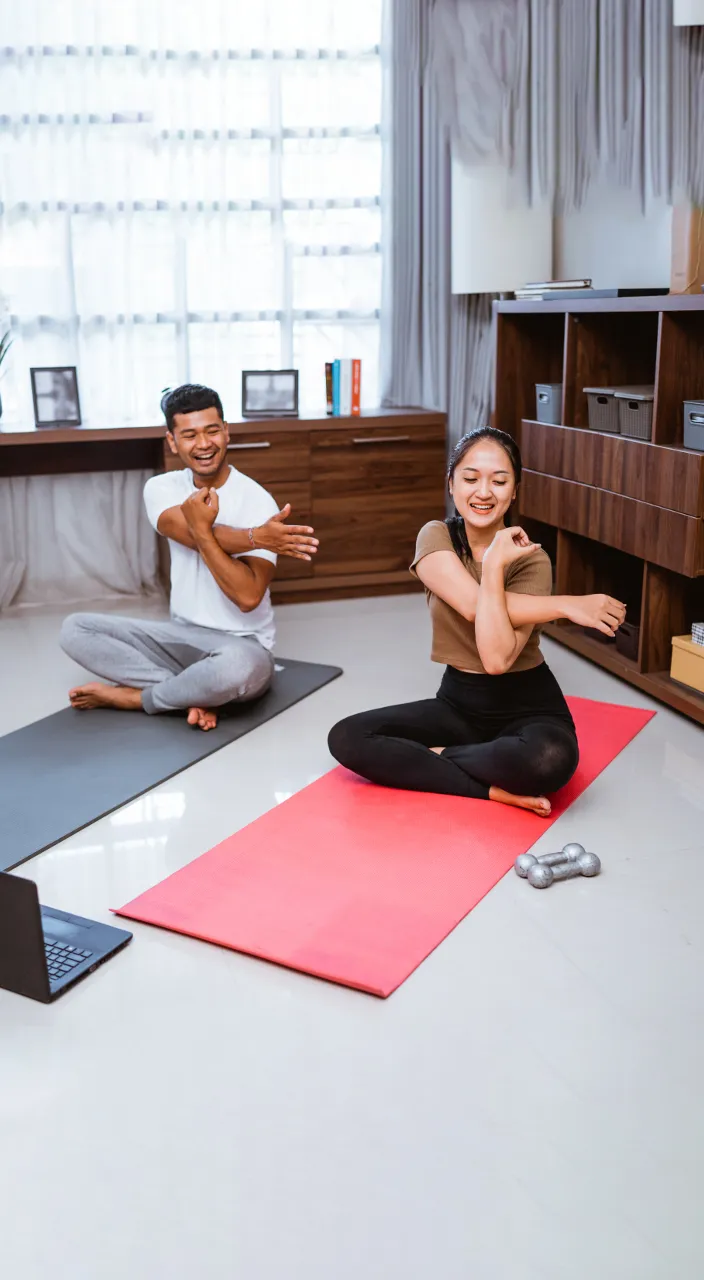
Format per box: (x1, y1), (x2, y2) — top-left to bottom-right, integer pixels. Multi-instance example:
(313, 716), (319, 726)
(553, 187), (672, 289)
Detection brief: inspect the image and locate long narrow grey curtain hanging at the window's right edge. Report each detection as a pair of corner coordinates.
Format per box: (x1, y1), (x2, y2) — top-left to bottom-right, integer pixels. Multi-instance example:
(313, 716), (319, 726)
(384, 0), (493, 447)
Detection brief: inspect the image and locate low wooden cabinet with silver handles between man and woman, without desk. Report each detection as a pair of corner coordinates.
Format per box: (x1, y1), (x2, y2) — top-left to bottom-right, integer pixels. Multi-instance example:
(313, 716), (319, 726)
(164, 410), (445, 603)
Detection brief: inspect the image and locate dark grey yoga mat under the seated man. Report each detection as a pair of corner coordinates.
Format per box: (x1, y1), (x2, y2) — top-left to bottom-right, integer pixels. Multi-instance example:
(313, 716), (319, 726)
(0, 658), (342, 870)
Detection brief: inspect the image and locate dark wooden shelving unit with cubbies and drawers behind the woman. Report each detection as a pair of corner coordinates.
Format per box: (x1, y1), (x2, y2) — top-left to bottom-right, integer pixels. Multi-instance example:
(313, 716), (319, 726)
(494, 296), (704, 724)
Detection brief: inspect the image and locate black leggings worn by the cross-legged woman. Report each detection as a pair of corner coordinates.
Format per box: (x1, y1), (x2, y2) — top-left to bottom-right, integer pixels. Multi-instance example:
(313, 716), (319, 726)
(328, 663), (579, 800)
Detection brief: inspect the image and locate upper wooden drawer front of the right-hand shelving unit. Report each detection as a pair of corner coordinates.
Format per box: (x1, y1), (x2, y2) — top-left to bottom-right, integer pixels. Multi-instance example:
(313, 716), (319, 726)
(521, 421), (704, 516)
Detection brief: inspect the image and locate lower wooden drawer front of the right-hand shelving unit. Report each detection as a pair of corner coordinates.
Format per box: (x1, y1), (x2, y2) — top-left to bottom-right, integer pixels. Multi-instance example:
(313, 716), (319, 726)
(520, 470), (704, 577)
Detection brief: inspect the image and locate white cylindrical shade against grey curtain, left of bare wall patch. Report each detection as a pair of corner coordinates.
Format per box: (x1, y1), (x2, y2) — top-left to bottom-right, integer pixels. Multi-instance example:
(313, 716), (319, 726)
(452, 161), (553, 293)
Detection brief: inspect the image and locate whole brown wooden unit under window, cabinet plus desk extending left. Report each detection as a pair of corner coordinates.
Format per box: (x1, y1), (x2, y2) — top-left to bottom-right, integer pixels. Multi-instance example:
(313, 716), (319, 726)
(0, 408), (445, 602)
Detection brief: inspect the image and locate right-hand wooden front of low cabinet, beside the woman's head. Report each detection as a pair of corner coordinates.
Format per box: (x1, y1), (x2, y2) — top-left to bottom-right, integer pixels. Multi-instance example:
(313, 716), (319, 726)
(312, 424), (445, 573)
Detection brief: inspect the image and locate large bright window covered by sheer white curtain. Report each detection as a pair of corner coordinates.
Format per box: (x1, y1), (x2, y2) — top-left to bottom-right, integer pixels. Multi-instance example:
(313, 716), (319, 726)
(0, 0), (381, 425)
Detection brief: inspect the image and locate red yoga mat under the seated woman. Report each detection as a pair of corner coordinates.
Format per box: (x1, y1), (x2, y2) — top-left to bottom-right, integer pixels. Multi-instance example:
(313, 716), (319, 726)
(116, 698), (654, 996)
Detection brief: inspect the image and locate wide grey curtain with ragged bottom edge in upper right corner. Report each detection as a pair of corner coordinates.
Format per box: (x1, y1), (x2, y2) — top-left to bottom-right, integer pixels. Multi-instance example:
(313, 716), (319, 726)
(426, 0), (704, 212)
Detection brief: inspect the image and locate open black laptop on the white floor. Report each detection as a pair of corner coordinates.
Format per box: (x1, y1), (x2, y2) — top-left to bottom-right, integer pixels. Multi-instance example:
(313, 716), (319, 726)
(0, 872), (132, 1005)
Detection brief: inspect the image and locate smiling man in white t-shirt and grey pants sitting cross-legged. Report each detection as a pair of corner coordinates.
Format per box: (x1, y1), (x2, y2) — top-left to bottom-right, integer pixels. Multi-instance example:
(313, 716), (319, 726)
(61, 385), (317, 730)
